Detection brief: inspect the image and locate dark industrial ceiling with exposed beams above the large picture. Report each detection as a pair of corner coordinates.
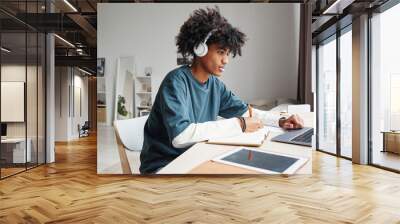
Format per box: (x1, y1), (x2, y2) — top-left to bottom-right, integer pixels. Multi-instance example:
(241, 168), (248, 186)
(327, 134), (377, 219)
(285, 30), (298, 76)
(0, 0), (387, 71)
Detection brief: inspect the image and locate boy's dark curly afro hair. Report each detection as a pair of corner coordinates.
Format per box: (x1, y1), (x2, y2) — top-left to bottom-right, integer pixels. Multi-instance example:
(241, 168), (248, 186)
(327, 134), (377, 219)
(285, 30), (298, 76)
(176, 6), (246, 58)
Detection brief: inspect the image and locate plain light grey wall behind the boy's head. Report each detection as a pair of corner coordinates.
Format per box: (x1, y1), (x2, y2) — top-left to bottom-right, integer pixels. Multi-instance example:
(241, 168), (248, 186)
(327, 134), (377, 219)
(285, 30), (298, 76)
(97, 3), (300, 124)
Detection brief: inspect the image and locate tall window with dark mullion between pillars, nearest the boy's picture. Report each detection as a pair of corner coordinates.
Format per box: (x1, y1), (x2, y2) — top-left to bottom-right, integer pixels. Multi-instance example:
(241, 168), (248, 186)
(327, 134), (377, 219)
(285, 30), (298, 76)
(316, 24), (353, 159)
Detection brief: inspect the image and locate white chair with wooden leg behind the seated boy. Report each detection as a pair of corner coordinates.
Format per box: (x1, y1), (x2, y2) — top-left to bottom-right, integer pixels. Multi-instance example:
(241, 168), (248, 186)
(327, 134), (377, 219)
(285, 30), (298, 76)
(114, 116), (148, 174)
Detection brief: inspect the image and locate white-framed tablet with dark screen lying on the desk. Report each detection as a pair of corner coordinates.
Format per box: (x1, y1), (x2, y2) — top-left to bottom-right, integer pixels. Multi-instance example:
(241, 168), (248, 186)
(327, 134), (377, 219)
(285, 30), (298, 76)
(213, 148), (308, 174)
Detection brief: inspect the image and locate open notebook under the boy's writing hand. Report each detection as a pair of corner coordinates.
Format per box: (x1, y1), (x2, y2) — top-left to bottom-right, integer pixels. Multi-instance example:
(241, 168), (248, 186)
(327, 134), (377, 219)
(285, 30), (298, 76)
(207, 127), (269, 146)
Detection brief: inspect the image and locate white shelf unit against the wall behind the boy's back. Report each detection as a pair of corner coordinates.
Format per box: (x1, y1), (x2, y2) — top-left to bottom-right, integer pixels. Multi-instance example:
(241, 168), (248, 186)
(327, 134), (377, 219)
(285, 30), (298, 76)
(135, 76), (153, 117)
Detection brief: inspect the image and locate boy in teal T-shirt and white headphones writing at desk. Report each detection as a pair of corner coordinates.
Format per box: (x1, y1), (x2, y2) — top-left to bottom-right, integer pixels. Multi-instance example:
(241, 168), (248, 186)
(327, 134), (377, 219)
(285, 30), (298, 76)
(140, 8), (303, 174)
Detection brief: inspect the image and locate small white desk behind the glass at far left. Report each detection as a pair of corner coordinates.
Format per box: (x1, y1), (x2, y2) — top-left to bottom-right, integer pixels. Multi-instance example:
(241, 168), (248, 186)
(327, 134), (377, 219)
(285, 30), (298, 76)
(1, 138), (32, 163)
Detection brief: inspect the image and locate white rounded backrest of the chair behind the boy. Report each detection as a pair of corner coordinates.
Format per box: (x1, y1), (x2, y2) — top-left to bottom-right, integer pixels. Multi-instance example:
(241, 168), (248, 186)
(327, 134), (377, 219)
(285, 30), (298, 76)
(114, 116), (148, 151)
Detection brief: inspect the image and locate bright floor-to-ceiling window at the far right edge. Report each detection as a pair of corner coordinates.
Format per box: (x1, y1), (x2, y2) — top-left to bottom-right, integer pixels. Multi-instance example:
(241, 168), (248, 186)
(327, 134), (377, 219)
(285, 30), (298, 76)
(370, 1), (400, 170)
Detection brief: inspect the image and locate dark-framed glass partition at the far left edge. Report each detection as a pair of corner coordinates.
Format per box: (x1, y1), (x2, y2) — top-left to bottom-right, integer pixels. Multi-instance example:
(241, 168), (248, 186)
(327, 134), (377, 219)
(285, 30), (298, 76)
(0, 1), (46, 179)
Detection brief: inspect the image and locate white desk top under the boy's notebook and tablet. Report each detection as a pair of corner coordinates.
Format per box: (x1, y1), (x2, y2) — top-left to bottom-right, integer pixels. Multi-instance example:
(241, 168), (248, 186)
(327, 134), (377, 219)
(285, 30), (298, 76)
(157, 112), (314, 174)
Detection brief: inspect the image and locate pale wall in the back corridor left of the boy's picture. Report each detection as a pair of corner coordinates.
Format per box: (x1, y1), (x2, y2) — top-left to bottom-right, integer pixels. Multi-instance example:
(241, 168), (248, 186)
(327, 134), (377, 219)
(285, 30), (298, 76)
(55, 67), (88, 141)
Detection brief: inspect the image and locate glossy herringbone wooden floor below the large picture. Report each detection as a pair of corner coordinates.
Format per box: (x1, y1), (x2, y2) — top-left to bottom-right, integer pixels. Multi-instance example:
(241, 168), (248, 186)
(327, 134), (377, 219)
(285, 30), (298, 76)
(0, 134), (400, 224)
